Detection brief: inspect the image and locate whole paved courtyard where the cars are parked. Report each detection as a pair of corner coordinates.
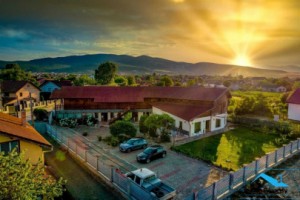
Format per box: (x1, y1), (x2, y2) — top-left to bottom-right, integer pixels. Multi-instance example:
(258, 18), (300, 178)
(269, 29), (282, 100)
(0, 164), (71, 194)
(56, 127), (228, 199)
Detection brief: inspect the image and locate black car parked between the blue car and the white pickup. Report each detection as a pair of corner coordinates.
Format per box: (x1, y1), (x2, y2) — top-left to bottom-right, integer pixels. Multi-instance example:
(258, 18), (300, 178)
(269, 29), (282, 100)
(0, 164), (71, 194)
(136, 145), (167, 163)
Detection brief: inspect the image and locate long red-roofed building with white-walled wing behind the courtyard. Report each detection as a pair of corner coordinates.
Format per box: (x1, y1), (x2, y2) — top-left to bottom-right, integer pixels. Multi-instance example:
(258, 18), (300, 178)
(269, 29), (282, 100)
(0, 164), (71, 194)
(51, 86), (231, 136)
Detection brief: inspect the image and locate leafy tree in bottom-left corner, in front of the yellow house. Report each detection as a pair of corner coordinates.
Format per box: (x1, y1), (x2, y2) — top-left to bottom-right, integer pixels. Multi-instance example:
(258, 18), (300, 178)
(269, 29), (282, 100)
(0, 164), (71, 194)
(0, 150), (66, 199)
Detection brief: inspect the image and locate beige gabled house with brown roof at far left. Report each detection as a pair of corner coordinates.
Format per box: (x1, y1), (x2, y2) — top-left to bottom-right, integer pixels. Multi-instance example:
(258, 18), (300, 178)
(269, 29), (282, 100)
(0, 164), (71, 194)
(1, 81), (40, 113)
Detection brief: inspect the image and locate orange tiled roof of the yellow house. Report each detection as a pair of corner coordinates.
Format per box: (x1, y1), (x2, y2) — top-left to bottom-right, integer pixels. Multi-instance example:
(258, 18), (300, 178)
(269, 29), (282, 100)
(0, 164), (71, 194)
(0, 113), (51, 147)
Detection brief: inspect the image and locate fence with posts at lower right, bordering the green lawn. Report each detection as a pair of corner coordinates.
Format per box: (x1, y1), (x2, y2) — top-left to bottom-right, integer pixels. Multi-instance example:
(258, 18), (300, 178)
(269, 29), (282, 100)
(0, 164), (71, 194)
(190, 139), (300, 200)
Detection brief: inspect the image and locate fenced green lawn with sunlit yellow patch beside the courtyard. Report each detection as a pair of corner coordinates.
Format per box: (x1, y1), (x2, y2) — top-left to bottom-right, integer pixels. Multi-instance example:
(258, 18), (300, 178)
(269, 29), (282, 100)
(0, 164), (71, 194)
(174, 127), (278, 170)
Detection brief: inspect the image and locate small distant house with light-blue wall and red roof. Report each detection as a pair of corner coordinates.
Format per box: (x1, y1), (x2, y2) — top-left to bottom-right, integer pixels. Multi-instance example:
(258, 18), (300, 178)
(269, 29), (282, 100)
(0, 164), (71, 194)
(40, 80), (72, 100)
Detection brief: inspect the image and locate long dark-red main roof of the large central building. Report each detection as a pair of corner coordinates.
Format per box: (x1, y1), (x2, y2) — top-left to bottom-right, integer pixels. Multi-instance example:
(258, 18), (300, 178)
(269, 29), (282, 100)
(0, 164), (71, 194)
(51, 86), (230, 102)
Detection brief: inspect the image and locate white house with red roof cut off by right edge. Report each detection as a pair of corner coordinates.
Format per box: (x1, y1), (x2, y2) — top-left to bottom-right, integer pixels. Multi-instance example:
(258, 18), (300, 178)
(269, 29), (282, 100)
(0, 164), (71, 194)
(287, 88), (300, 121)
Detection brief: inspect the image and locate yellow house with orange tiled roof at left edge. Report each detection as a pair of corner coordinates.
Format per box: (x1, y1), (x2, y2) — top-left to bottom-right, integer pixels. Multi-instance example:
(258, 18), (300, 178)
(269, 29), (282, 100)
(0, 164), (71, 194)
(0, 113), (52, 164)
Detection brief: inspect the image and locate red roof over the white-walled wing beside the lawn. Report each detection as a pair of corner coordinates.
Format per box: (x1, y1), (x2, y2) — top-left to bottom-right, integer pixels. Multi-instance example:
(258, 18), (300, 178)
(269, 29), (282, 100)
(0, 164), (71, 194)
(151, 103), (213, 121)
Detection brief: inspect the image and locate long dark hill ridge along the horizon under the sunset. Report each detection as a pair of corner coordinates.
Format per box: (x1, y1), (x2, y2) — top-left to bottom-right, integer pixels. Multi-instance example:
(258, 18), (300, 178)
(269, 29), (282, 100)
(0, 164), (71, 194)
(0, 54), (295, 77)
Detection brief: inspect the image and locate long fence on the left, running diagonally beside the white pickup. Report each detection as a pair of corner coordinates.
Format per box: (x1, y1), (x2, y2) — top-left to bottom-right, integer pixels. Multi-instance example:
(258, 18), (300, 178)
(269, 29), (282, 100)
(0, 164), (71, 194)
(42, 123), (157, 200)
